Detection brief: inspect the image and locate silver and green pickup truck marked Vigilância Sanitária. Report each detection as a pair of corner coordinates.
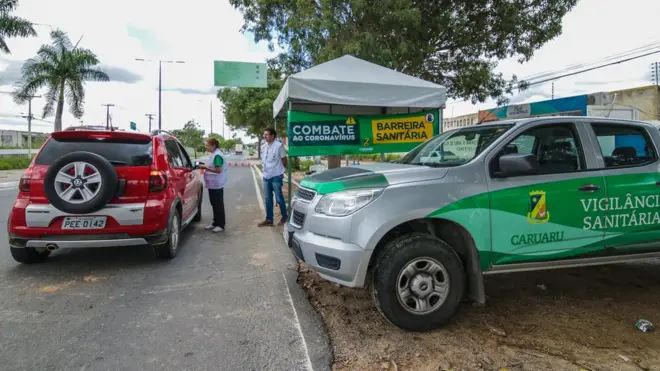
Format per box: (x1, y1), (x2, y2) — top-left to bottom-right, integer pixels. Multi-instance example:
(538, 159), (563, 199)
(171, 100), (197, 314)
(285, 117), (660, 331)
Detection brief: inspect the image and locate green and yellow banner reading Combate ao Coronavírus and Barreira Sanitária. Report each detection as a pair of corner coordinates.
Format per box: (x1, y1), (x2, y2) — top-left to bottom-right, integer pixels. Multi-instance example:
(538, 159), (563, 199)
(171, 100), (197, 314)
(287, 110), (440, 156)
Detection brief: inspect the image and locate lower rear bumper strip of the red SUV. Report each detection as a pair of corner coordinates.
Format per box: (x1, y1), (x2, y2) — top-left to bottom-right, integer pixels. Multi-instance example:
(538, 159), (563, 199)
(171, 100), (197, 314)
(9, 231), (168, 249)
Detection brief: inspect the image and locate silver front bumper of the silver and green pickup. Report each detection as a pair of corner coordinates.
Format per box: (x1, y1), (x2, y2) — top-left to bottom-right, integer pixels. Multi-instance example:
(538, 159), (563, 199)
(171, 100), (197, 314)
(284, 223), (371, 287)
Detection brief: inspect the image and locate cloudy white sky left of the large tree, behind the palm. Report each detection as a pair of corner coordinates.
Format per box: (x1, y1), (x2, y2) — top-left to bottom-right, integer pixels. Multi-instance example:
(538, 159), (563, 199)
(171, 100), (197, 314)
(0, 0), (272, 140)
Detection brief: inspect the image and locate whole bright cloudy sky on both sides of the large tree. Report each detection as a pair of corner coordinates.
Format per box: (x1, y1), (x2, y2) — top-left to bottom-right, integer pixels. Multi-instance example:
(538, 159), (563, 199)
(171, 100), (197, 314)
(0, 0), (660, 140)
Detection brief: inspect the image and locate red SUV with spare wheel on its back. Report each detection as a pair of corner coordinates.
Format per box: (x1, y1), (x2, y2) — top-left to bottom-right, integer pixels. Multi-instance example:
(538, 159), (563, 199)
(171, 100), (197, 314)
(7, 128), (203, 263)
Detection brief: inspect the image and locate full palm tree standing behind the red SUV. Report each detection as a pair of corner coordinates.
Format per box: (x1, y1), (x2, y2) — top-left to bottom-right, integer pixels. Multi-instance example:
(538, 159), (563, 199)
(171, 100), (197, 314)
(12, 29), (110, 131)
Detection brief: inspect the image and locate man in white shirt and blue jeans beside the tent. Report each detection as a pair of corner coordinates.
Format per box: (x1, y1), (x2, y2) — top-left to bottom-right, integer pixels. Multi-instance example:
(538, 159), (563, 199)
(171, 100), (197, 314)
(258, 128), (288, 227)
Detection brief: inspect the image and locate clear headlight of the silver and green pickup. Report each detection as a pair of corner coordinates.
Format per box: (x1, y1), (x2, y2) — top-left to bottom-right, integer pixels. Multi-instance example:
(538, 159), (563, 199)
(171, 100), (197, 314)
(314, 188), (383, 216)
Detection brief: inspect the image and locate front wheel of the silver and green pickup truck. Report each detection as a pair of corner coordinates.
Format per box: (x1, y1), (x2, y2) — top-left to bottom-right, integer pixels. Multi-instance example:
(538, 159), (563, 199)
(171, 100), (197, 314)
(371, 233), (466, 332)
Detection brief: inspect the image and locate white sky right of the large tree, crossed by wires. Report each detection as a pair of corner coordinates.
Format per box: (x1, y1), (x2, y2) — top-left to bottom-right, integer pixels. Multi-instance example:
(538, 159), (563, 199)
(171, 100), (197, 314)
(445, 0), (660, 117)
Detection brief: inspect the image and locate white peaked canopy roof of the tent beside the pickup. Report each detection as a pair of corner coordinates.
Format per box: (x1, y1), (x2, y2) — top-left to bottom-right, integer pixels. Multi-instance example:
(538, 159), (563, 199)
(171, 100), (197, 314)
(273, 55), (447, 117)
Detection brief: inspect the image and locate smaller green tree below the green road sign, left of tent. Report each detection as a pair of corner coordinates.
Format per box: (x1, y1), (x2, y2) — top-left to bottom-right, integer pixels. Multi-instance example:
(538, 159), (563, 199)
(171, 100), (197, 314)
(218, 75), (284, 157)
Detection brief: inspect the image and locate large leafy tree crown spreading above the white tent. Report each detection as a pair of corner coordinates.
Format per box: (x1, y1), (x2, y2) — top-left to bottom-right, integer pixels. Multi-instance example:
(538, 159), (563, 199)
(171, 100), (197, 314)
(230, 0), (578, 104)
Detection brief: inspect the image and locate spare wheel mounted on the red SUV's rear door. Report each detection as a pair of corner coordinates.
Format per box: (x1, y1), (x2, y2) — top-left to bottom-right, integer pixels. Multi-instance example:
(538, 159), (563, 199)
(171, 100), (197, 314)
(44, 151), (118, 214)
